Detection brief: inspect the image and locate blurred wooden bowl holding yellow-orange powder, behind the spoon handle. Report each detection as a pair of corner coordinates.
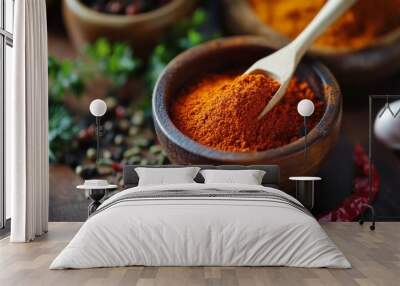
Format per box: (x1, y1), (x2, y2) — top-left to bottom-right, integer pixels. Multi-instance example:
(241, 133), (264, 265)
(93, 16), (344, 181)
(223, 0), (400, 86)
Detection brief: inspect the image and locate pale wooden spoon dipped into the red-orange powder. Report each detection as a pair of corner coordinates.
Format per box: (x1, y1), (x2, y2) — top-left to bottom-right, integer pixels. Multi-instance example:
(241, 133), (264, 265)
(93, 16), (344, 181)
(244, 0), (357, 119)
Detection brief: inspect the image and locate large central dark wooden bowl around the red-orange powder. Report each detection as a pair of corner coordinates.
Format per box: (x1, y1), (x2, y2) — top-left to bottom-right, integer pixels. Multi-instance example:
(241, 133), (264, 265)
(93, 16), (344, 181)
(153, 37), (342, 188)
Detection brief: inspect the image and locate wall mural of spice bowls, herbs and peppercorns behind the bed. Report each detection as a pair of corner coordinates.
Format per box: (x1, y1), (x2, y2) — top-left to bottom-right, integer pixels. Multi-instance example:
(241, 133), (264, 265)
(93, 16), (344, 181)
(47, 0), (400, 221)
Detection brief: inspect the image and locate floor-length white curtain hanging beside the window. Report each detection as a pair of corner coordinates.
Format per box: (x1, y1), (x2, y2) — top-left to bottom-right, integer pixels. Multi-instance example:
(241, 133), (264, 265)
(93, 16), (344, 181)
(6, 0), (49, 242)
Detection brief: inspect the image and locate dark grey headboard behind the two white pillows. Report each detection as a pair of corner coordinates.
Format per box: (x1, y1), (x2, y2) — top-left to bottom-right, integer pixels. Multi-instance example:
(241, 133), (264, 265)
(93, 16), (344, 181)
(123, 165), (280, 189)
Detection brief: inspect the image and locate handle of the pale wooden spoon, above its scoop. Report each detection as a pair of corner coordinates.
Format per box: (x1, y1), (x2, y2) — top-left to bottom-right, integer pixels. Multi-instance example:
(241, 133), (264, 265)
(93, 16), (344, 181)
(290, 0), (357, 65)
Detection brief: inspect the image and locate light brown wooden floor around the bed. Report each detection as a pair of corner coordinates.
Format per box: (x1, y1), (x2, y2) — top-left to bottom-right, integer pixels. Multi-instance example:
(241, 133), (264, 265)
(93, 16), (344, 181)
(0, 222), (400, 286)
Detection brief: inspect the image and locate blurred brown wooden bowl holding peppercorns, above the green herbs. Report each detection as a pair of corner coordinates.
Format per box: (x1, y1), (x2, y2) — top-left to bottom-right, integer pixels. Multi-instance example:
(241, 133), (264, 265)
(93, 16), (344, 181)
(63, 0), (196, 56)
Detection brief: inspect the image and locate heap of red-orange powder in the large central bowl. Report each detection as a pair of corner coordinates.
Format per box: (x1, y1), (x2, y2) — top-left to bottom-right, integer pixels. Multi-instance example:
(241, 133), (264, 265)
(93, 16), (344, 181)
(170, 74), (324, 152)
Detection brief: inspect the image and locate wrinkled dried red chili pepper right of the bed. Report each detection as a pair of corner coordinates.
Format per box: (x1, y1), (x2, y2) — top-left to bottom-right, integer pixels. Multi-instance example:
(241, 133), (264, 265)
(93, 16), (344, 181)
(317, 145), (380, 222)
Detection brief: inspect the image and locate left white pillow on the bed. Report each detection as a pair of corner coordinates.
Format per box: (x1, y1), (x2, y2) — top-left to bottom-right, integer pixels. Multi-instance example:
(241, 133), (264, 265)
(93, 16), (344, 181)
(135, 167), (200, 186)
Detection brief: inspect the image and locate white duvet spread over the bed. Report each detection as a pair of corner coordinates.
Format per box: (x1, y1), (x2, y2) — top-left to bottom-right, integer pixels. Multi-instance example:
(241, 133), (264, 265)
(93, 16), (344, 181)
(50, 184), (351, 269)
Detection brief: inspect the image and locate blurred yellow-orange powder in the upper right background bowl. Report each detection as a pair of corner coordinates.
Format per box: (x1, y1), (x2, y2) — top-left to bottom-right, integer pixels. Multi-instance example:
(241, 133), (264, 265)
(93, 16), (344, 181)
(248, 0), (400, 49)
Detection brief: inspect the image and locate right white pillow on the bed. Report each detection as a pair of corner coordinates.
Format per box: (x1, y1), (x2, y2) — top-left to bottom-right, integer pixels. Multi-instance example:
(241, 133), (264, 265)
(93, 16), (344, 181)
(200, 170), (265, 185)
